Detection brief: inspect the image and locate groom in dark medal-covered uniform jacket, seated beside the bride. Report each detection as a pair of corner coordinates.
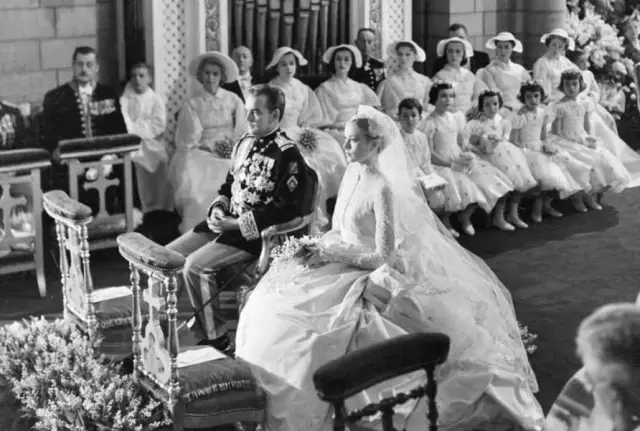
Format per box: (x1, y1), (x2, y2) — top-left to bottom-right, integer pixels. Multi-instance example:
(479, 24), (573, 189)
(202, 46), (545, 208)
(167, 85), (307, 353)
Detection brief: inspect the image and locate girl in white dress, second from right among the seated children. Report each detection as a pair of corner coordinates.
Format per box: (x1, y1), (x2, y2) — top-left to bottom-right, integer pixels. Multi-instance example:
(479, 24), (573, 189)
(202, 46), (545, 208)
(511, 81), (591, 223)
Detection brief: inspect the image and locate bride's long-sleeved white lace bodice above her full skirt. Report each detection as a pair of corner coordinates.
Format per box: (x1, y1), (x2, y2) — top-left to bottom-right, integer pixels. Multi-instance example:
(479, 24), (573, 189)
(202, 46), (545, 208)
(324, 163), (395, 269)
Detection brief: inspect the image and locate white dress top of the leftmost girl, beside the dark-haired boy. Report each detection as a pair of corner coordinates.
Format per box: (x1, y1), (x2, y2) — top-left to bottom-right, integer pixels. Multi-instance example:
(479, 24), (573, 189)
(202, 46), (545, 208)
(421, 112), (464, 165)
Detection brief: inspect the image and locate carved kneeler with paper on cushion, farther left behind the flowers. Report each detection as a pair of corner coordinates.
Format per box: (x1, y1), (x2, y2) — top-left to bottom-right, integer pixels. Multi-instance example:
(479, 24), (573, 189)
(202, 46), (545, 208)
(44, 190), (133, 361)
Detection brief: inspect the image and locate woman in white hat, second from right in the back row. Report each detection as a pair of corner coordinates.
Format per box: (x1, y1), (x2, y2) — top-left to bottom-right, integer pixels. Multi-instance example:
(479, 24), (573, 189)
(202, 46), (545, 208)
(476, 31), (531, 118)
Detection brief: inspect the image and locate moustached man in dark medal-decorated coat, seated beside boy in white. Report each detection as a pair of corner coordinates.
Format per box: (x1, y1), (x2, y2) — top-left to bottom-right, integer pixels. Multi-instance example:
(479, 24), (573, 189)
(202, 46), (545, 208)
(40, 46), (130, 213)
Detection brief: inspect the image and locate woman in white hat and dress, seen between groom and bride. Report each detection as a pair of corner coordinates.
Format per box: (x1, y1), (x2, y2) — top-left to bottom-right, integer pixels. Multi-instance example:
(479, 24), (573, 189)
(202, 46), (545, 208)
(267, 46), (347, 234)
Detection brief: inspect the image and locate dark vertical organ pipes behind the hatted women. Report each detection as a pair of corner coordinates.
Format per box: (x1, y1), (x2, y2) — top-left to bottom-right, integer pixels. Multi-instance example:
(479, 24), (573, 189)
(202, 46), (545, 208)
(228, 0), (353, 75)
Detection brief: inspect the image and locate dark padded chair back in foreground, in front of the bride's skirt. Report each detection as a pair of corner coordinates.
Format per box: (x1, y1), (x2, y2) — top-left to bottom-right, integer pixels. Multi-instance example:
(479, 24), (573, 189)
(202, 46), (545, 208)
(313, 333), (450, 431)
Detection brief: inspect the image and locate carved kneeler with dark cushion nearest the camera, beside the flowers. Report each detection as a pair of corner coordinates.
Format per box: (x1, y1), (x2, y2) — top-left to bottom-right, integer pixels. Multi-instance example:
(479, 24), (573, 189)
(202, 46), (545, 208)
(118, 233), (265, 430)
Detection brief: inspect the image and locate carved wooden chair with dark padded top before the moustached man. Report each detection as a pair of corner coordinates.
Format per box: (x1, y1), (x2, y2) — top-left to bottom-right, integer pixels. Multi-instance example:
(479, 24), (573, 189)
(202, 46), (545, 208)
(58, 134), (140, 249)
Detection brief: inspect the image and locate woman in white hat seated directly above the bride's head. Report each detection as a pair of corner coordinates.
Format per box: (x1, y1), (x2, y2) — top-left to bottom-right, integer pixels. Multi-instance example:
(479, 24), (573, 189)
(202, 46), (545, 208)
(316, 44), (380, 142)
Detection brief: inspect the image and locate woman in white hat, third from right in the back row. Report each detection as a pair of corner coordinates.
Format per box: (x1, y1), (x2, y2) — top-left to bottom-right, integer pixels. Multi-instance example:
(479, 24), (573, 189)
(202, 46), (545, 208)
(433, 37), (487, 115)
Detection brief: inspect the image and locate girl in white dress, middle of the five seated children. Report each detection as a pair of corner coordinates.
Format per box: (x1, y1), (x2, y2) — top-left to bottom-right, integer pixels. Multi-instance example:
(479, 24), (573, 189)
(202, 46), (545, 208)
(467, 90), (538, 231)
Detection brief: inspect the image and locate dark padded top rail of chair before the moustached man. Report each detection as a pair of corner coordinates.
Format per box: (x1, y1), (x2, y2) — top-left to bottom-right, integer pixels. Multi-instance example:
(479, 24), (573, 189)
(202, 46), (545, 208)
(58, 133), (140, 160)
